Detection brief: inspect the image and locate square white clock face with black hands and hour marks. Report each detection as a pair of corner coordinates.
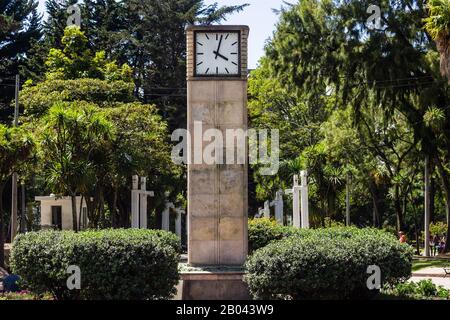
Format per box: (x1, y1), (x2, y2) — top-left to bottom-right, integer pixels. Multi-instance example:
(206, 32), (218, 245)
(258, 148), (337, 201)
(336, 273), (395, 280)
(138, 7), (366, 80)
(195, 31), (240, 77)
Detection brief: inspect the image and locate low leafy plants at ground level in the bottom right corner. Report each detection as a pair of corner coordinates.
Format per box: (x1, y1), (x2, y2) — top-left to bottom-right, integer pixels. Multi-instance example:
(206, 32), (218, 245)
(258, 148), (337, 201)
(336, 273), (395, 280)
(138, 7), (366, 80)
(383, 279), (450, 300)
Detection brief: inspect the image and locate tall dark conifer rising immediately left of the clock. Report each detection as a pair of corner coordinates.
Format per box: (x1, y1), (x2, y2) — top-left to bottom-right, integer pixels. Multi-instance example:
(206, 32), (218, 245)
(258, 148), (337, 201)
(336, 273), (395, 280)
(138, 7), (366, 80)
(39, 0), (246, 131)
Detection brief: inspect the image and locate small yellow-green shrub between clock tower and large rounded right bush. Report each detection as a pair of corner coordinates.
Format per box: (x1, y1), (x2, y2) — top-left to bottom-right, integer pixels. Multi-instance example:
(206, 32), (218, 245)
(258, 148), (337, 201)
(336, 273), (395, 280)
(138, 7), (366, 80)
(248, 218), (299, 252)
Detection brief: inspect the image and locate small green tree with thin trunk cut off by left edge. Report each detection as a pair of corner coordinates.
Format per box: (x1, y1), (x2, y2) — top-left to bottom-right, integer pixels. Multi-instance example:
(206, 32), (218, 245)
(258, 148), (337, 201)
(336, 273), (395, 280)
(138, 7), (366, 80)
(0, 124), (34, 267)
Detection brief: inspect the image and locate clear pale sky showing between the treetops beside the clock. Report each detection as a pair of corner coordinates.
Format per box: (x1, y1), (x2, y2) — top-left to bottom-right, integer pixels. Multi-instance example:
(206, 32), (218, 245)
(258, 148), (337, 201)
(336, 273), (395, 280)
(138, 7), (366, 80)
(39, 0), (283, 69)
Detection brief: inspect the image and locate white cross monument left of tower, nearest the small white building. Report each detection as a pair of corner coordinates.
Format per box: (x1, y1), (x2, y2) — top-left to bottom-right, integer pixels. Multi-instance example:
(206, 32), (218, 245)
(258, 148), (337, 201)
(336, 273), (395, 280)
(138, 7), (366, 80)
(131, 175), (154, 229)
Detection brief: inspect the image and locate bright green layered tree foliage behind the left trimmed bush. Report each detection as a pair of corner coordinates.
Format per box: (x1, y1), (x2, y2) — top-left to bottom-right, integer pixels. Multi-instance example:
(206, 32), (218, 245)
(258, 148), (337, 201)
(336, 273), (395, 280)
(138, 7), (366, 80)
(20, 27), (182, 227)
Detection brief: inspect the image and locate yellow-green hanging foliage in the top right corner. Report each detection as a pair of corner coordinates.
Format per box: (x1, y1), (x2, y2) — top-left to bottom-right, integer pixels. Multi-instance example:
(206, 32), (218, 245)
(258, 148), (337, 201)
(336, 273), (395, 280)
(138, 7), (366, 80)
(424, 0), (450, 40)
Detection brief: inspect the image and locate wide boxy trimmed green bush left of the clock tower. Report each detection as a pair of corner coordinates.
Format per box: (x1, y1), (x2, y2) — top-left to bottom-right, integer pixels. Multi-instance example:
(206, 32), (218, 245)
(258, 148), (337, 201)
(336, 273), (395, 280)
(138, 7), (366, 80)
(11, 229), (180, 300)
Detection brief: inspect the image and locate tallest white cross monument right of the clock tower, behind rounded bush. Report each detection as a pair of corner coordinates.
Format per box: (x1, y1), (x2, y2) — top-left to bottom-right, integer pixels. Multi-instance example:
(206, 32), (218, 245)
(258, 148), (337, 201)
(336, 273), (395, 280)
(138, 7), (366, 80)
(285, 170), (309, 229)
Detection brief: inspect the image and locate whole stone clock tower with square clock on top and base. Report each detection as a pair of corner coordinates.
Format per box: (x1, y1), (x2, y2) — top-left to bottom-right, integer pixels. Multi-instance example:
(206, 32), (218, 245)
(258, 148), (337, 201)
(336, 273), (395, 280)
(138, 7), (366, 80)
(182, 26), (249, 299)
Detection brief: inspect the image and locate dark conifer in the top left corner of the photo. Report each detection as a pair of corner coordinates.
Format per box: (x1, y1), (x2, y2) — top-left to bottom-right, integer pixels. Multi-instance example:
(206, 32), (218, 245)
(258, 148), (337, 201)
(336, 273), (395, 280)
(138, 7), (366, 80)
(0, 0), (41, 122)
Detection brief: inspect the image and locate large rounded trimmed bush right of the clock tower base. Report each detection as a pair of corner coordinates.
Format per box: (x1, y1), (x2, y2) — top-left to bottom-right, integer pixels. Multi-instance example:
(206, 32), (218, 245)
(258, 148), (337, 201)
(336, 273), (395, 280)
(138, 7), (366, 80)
(244, 227), (413, 299)
